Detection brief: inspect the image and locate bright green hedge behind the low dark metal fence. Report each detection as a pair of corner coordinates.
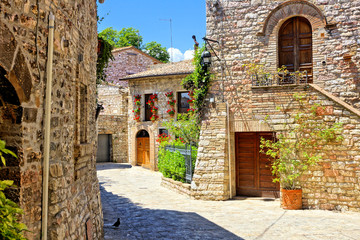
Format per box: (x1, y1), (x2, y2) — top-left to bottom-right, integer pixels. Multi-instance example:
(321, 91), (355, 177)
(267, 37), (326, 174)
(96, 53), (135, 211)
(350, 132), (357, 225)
(158, 141), (197, 182)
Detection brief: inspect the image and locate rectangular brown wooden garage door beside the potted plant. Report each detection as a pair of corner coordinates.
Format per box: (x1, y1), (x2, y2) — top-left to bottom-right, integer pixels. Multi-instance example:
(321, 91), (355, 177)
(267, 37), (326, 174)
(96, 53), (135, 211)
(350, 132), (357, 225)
(235, 132), (279, 197)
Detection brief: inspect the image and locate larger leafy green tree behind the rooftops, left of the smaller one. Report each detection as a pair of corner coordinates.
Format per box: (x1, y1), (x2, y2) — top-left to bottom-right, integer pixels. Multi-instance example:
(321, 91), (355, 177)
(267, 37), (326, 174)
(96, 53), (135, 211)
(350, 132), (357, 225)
(99, 27), (143, 49)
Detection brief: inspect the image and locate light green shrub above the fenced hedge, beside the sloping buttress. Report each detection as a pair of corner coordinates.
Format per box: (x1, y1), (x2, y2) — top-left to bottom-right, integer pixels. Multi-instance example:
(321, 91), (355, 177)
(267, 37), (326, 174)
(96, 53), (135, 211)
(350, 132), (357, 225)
(163, 113), (200, 146)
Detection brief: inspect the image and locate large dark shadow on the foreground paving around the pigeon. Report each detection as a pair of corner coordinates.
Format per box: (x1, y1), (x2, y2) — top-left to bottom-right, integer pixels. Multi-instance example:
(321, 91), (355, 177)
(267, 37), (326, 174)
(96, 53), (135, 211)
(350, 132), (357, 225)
(100, 182), (243, 240)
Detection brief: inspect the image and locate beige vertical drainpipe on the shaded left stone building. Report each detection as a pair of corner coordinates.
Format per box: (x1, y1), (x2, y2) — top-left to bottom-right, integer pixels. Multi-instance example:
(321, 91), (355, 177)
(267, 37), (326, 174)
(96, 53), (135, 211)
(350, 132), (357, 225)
(41, 12), (55, 240)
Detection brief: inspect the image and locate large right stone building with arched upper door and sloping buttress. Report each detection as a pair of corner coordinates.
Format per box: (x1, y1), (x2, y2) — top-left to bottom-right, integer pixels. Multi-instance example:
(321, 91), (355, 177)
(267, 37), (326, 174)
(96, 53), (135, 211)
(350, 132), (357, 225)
(191, 0), (360, 211)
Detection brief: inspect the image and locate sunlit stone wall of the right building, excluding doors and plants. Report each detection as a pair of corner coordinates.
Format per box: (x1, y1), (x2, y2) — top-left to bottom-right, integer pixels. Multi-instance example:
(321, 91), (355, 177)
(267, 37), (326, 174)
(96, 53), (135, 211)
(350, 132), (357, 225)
(195, 0), (360, 210)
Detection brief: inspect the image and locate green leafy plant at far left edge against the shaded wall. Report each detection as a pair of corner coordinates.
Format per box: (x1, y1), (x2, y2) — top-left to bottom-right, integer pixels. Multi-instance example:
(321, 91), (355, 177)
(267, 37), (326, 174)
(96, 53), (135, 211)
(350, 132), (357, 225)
(0, 140), (27, 240)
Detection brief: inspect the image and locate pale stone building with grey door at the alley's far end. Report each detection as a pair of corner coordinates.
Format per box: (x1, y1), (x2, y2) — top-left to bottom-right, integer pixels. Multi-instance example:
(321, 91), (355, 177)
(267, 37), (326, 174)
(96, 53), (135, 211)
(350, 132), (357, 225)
(96, 84), (129, 163)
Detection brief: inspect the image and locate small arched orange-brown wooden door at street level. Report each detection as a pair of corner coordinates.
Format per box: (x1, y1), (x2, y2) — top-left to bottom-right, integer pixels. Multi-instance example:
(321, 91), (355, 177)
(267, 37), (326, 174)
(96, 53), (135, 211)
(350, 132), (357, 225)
(136, 130), (150, 168)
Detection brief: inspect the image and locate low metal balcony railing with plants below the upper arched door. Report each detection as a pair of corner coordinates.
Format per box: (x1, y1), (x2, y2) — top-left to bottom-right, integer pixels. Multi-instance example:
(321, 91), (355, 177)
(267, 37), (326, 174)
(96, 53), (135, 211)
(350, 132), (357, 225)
(251, 71), (309, 87)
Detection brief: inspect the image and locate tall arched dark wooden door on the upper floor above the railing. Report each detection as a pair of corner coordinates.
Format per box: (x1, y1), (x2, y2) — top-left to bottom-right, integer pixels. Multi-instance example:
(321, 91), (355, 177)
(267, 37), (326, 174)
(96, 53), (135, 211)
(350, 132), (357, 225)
(279, 17), (313, 83)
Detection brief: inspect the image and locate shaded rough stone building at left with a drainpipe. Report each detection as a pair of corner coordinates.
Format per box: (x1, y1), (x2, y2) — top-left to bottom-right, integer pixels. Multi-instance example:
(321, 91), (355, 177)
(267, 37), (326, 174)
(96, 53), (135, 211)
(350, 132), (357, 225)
(0, 0), (103, 239)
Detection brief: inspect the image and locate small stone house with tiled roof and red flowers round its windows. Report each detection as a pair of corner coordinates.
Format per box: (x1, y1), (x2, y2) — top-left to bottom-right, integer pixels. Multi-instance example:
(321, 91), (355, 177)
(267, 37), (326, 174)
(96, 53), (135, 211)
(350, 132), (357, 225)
(122, 60), (194, 170)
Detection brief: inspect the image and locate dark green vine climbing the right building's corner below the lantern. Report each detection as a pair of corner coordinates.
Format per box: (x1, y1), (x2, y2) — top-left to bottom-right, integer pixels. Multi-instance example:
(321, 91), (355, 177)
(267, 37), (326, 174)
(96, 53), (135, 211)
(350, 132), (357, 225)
(181, 46), (212, 113)
